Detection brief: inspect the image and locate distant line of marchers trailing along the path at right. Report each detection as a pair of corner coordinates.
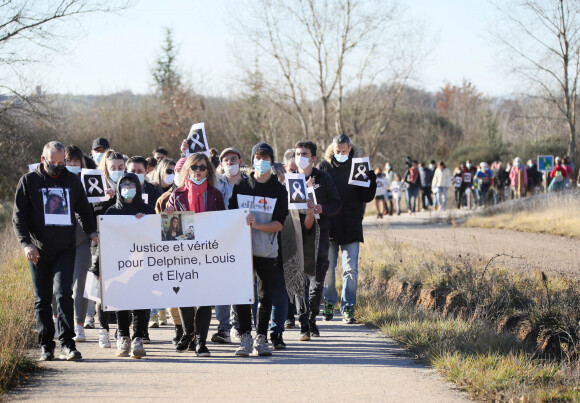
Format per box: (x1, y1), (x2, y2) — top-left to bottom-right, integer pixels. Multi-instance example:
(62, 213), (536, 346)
(375, 157), (580, 218)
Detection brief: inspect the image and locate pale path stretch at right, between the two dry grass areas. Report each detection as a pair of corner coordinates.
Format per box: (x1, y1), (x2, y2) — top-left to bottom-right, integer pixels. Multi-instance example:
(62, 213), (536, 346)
(364, 213), (580, 278)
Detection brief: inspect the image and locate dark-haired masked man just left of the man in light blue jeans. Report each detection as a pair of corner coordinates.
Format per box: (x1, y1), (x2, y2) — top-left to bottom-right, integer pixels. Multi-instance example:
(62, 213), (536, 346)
(294, 141), (340, 338)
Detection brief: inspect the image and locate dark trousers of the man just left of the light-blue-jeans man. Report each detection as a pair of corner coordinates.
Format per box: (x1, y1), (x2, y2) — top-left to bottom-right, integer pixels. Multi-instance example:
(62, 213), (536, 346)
(296, 231), (330, 325)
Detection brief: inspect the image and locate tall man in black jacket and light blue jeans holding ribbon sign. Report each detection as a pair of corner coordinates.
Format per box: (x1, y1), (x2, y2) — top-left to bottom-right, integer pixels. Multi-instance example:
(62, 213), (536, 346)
(323, 134), (377, 323)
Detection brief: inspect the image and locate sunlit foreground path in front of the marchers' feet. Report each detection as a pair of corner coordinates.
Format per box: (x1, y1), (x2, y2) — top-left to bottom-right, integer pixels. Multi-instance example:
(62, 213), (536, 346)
(7, 318), (465, 402)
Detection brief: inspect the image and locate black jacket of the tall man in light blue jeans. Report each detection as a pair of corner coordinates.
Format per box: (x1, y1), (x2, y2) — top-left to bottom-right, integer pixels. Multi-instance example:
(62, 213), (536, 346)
(326, 144), (377, 245)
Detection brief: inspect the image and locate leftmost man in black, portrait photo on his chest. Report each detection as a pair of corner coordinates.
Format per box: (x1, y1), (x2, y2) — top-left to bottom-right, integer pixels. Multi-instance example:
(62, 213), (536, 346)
(12, 141), (97, 361)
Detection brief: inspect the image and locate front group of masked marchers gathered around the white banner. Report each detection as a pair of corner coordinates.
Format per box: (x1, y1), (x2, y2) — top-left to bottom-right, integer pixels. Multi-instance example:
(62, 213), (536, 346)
(12, 134), (378, 360)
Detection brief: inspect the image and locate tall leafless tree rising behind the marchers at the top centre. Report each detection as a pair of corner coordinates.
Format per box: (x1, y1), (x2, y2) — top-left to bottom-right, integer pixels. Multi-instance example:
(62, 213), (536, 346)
(231, 0), (416, 149)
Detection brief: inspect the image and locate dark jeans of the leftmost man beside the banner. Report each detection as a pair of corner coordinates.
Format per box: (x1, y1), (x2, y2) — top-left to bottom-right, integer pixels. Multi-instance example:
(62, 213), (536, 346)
(29, 245), (76, 349)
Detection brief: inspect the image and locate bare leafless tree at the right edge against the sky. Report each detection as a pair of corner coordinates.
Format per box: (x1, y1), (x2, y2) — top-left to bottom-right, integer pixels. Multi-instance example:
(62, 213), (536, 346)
(495, 0), (580, 167)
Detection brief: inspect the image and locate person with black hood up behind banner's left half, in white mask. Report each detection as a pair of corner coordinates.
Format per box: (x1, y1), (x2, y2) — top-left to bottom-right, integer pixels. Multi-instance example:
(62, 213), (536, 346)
(105, 173), (155, 358)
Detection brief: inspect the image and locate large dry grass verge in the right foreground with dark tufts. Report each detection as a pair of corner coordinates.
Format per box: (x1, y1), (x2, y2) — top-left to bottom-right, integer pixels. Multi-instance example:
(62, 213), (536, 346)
(357, 239), (580, 401)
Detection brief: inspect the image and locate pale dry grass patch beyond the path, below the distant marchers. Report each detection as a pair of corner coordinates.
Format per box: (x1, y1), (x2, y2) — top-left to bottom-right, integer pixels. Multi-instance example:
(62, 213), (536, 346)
(465, 192), (580, 239)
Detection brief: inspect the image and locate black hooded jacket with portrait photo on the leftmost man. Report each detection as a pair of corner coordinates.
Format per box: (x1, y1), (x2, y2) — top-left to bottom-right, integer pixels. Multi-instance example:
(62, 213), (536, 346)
(12, 164), (97, 254)
